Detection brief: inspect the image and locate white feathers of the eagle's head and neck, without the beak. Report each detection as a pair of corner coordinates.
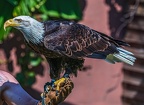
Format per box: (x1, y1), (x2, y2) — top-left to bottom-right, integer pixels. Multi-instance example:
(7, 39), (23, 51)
(15, 16), (44, 44)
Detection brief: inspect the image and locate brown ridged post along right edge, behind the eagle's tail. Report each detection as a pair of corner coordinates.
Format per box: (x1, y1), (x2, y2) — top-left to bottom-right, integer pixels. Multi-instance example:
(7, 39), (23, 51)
(122, 0), (144, 105)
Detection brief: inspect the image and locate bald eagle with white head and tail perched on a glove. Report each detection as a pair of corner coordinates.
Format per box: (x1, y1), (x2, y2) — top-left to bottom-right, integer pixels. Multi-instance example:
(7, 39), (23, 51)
(4, 16), (136, 89)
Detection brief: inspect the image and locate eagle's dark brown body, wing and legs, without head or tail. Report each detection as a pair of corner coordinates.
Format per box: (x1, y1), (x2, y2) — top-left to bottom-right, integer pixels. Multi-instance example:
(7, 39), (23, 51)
(28, 21), (130, 79)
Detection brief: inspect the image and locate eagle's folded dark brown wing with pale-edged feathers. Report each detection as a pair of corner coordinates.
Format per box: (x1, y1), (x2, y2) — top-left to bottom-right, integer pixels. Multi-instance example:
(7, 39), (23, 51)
(44, 21), (127, 58)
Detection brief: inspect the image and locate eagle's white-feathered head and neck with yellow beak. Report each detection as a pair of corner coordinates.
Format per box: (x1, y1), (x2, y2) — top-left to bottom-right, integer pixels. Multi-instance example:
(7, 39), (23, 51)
(4, 16), (44, 44)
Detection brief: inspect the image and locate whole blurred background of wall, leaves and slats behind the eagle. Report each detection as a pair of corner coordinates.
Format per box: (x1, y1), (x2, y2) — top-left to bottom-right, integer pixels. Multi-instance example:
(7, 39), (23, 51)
(0, 0), (144, 105)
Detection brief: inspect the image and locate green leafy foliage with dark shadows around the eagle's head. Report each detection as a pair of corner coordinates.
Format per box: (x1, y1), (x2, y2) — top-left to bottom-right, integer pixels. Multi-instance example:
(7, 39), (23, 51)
(0, 0), (82, 86)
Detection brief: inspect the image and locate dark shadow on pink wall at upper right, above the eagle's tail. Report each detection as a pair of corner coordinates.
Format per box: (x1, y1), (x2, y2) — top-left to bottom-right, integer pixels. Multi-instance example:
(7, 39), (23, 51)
(105, 0), (128, 39)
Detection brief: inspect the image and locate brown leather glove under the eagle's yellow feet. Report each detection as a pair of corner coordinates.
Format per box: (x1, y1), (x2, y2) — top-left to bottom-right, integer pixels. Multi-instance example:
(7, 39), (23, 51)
(38, 78), (74, 105)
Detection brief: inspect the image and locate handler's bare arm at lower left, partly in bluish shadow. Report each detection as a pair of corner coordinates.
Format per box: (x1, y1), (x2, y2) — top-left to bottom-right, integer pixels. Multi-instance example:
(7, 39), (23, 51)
(0, 70), (38, 105)
